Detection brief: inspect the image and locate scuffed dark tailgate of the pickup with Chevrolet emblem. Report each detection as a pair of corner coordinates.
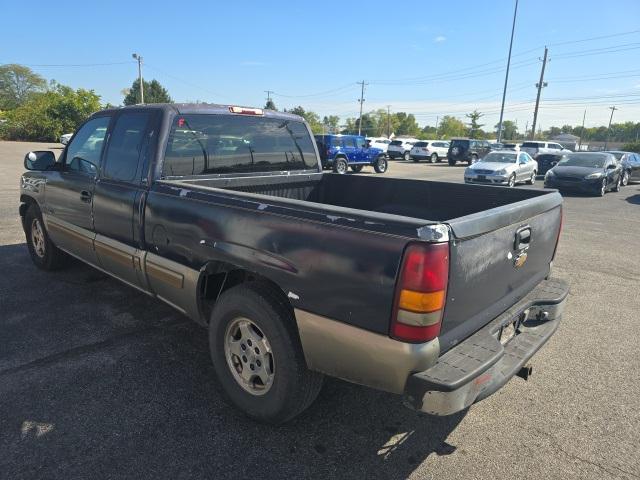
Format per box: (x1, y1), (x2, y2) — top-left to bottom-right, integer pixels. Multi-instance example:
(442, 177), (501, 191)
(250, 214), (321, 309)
(440, 192), (562, 351)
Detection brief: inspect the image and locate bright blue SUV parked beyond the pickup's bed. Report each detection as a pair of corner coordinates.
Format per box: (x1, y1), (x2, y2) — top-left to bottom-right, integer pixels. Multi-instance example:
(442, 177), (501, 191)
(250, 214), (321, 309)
(315, 135), (388, 174)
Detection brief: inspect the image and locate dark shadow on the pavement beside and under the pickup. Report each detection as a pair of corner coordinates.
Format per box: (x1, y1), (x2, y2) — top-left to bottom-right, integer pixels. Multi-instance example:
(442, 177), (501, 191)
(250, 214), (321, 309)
(0, 244), (466, 479)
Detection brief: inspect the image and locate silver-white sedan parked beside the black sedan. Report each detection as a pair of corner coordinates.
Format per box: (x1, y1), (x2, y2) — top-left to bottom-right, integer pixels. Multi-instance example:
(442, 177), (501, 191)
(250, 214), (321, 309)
(464, 150), (538, 187)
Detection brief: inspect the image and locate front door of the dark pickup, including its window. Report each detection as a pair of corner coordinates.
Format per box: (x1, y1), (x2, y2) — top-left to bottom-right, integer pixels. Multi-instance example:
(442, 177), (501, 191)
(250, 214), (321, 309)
(43, 115), (111, 265)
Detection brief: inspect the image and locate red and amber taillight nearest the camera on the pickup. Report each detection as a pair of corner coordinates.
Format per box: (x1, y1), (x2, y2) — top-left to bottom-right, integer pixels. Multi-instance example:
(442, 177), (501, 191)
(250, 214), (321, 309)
(391, 243), (449, 343)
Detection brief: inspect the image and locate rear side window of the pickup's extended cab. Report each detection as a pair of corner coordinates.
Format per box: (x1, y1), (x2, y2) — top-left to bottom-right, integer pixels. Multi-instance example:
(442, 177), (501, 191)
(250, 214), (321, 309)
(102, 112), (150, 182)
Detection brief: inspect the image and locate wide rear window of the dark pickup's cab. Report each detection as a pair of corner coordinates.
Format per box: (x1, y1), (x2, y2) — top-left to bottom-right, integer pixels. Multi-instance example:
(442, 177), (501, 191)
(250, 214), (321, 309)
(163, 114), (318, 175)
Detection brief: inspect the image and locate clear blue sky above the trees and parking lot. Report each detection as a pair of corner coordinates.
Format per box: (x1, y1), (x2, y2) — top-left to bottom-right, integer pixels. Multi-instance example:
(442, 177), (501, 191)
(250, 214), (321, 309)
(0, 0), (640, 130)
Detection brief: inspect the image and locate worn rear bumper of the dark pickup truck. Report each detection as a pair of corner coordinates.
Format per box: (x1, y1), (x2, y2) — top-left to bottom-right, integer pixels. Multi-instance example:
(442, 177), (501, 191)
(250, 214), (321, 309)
(404, 279), (569, 415)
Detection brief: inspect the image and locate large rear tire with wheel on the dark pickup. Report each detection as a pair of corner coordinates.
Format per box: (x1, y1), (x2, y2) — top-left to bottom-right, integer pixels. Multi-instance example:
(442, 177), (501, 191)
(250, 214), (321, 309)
(209, 282), (324, 424)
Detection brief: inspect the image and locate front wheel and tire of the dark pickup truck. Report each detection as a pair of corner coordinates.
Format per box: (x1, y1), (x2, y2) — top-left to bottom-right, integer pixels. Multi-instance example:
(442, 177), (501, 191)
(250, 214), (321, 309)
(24, 205), (69, 271)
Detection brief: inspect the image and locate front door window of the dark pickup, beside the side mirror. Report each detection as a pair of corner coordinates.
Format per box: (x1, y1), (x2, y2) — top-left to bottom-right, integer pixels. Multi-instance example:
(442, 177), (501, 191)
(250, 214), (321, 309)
(65, 116), (111, 175)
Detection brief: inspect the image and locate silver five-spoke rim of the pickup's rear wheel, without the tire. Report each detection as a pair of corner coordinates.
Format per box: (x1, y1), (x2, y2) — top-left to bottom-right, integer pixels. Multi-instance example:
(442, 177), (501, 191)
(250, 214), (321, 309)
(224, 317), (275, 395)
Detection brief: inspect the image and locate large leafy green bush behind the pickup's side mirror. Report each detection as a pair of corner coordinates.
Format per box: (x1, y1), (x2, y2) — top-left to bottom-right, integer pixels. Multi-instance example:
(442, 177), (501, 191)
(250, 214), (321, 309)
(3, 83), (100, 141)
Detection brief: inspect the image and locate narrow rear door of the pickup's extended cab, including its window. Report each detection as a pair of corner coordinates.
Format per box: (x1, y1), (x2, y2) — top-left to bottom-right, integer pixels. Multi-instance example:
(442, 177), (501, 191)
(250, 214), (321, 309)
(93, 111), (155, 291)
